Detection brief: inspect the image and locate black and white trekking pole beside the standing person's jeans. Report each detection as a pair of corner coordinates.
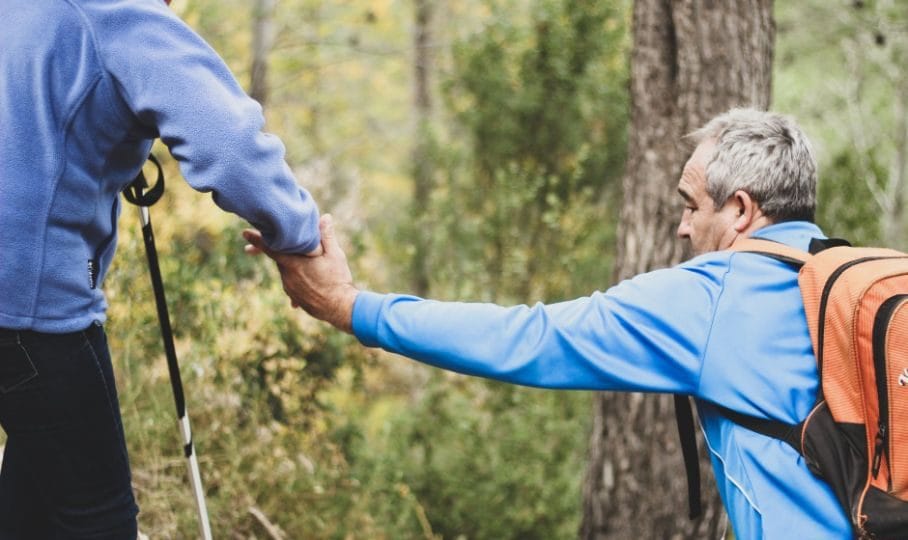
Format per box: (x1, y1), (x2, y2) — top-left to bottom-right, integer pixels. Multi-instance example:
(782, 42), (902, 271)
(123, 154), (211, 540)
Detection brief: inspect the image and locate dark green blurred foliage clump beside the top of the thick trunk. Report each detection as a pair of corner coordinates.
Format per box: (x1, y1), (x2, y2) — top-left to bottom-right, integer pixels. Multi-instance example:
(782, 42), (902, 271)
(449, 0), (627, 186)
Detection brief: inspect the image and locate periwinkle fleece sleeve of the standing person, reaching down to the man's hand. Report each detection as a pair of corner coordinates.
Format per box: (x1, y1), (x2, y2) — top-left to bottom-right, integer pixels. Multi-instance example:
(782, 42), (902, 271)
(92, 0), (320, 253)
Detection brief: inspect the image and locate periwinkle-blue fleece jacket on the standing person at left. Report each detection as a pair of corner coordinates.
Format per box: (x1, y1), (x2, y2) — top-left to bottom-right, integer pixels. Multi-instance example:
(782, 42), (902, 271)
(0, 0), (319, 332)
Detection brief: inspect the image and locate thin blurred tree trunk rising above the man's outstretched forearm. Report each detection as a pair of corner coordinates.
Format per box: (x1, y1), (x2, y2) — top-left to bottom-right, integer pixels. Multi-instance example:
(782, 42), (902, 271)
(411, 0), (436, 297)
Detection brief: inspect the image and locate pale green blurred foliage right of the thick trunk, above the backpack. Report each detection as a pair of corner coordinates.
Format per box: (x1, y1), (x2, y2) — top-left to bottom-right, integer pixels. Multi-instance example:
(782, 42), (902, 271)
(774, 0), (908, 249)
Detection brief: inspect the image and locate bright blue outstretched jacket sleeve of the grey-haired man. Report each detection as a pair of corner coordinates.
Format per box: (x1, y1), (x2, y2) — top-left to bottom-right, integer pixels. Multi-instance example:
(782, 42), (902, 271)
(353, 260), (724, 395)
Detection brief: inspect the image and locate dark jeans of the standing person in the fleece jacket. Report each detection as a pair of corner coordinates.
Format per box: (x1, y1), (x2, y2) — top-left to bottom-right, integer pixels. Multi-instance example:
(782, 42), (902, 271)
(0, 324), (139, 540)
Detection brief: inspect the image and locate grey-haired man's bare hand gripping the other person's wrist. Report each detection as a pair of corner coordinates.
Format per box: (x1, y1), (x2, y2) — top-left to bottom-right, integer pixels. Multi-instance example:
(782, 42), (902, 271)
(243, 214), (359, 333)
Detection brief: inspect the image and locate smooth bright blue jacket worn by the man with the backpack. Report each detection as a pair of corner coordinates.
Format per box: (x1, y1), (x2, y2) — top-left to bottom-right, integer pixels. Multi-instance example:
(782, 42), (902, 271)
(353, 222), (851, 540)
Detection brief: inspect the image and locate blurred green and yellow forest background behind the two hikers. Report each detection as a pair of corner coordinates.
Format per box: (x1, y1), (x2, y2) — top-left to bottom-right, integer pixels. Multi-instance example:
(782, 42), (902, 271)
(8, 0), (908, 539)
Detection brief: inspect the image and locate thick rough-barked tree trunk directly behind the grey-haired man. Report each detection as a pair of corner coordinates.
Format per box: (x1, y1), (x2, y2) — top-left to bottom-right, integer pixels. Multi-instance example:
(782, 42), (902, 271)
(580, 0), (775, 540)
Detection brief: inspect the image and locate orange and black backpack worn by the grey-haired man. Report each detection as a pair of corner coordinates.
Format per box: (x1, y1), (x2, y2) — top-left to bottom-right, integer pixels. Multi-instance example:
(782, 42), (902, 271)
(708, 239), (908, 539)
